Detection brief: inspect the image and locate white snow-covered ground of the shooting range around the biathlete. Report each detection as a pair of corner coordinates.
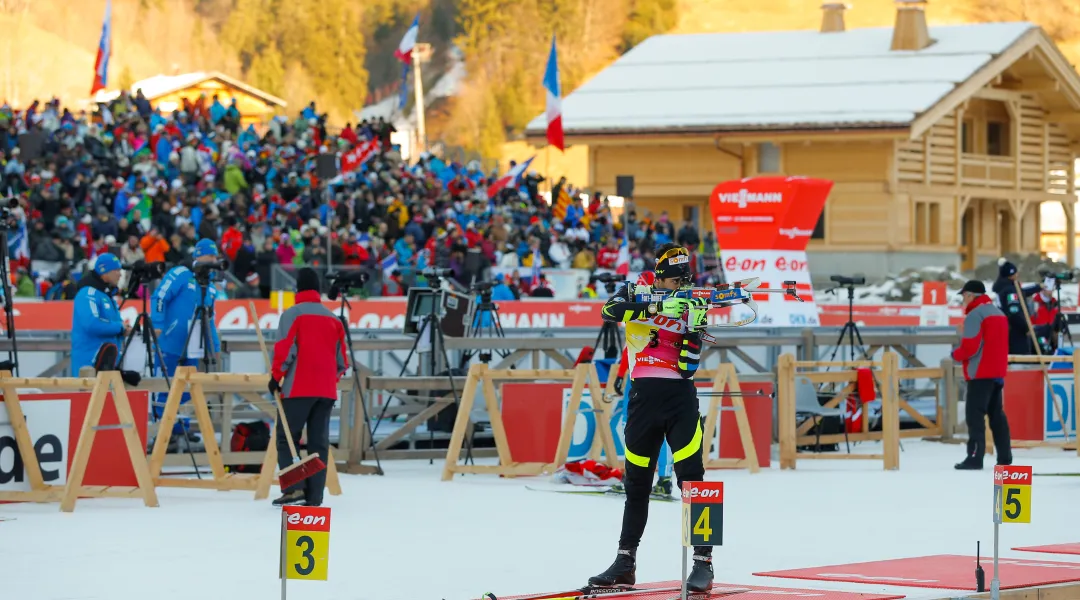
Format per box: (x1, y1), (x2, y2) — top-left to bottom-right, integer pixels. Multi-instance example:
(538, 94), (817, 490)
(0, 440), (1080, 600)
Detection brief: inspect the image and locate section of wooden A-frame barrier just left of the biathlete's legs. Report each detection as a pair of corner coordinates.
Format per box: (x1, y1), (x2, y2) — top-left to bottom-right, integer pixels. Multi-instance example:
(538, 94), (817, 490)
(443, 363), (619, 481)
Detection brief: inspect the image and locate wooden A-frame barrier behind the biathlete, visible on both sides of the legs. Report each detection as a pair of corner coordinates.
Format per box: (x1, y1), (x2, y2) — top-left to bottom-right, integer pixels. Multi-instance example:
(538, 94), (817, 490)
(443, 363), (760, 481)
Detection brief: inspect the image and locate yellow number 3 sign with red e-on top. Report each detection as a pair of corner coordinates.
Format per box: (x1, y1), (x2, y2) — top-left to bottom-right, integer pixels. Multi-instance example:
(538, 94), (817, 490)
(279, 506), (330, 582)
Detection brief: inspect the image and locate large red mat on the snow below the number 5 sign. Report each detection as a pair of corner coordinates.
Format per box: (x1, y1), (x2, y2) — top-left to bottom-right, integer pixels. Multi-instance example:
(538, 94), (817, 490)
(754, 555), (1080, 591)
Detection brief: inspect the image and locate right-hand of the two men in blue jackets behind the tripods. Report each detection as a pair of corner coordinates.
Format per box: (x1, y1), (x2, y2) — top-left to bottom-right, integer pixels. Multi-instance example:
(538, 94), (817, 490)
(150, 238), (221, 434)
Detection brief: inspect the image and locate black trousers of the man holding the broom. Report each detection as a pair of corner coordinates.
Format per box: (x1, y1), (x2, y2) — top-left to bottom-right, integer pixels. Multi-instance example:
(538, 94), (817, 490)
(278, 398), (334, 504)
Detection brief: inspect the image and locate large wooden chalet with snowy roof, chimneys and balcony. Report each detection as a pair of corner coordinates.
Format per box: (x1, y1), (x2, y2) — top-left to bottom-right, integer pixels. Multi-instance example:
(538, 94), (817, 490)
(526, 0), (1080, 271)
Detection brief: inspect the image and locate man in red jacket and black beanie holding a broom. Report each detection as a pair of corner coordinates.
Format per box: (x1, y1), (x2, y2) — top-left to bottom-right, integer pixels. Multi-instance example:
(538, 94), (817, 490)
(269, 268), (349, 506)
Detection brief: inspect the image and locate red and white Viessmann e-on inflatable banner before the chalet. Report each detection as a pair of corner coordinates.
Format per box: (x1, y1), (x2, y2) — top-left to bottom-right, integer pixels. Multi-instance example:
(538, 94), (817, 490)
(708, 177), (842, 327)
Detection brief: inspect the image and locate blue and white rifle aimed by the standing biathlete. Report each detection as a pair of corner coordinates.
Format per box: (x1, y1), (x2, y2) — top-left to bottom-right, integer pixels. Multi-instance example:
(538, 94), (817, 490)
(635, 277), (806, 343)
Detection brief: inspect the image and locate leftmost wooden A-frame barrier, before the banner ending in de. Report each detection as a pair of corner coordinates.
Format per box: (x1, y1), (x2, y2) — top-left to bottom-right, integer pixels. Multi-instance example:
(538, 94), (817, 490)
(0, 371), (158, 513)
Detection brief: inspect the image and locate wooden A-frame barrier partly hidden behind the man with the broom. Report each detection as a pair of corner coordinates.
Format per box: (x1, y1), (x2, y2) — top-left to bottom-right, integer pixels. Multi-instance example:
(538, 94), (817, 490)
(150, 367), (341, 500)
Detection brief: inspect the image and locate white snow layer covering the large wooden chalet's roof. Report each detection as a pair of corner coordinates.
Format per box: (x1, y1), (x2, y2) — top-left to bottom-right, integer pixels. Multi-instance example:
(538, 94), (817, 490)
(527, 23), (1036, 133)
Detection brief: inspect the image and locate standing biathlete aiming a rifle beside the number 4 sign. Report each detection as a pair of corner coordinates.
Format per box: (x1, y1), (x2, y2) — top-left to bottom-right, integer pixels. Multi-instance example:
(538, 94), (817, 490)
(589, 244), (713, 591)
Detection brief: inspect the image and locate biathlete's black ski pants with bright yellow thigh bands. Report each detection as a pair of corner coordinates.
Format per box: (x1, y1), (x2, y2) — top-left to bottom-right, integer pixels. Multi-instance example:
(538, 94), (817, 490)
(619, 378), (712, 555)
